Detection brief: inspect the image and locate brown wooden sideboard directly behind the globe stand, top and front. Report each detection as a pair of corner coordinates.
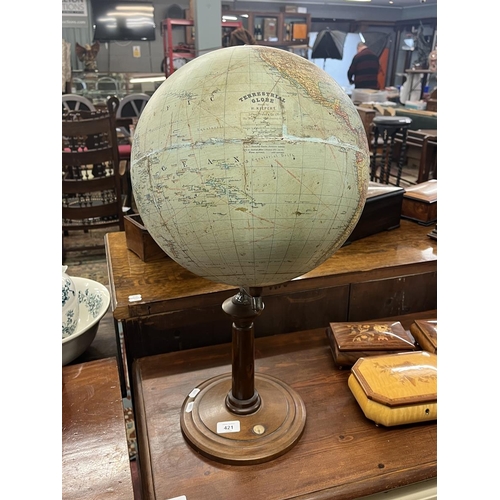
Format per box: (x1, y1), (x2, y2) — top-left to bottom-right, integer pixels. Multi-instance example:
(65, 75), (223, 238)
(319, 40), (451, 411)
(105, 220), (437, 386)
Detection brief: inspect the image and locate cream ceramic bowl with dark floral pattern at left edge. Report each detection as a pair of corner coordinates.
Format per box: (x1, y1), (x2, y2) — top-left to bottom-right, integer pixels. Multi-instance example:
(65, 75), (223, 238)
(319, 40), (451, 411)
(62, 276), (111, 366)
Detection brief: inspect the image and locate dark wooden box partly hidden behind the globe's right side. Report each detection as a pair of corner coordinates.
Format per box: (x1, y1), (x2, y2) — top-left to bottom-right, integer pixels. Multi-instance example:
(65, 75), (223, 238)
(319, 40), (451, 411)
(345, 182), (405, 245)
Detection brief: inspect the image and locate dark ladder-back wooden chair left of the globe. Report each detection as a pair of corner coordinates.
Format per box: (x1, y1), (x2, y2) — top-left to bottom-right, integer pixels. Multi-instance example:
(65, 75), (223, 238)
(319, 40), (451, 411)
(62, 97), (124, 257)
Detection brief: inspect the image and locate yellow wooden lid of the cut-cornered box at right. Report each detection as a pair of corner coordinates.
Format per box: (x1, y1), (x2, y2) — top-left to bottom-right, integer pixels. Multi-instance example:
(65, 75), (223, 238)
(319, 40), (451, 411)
(351, 351), (437, 407)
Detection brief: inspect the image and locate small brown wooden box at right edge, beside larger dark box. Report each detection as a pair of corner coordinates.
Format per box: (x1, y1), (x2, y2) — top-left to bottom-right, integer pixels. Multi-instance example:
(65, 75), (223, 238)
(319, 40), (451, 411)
(401, 179), (437, 226)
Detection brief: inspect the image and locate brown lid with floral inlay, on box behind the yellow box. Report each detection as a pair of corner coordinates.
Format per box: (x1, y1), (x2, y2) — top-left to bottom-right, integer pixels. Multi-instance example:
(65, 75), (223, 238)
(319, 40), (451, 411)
(330, 321), (415, 352)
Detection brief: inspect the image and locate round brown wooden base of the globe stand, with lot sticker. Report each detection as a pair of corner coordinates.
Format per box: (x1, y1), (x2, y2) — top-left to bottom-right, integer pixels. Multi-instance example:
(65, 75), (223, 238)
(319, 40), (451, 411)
(181, 374), (306, 465)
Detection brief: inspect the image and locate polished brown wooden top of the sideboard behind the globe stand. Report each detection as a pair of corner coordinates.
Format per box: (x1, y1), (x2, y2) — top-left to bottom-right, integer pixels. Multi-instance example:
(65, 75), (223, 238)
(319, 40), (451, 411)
(105, 220), (437, 321)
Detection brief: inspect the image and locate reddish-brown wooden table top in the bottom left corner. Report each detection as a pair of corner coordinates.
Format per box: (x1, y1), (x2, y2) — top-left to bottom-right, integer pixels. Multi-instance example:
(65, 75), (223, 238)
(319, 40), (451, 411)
(62, 358), (134, 500)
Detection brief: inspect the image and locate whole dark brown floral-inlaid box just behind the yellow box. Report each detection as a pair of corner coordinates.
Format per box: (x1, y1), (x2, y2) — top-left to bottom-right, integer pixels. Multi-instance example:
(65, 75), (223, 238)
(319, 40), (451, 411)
(326, 321), (415, 368)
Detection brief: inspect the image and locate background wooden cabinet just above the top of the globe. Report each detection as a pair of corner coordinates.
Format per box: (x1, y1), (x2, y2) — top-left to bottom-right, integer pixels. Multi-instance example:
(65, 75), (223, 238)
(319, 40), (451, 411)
(222, 11), (311, 47)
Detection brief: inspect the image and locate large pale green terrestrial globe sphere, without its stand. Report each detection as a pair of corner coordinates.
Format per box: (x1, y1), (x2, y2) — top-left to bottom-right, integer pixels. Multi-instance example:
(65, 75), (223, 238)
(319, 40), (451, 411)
(131, 45), (369, 287)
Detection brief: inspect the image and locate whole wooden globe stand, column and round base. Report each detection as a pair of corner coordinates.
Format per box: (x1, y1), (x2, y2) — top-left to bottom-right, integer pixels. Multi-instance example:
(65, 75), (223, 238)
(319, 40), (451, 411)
(181, 288), (306, 465)
